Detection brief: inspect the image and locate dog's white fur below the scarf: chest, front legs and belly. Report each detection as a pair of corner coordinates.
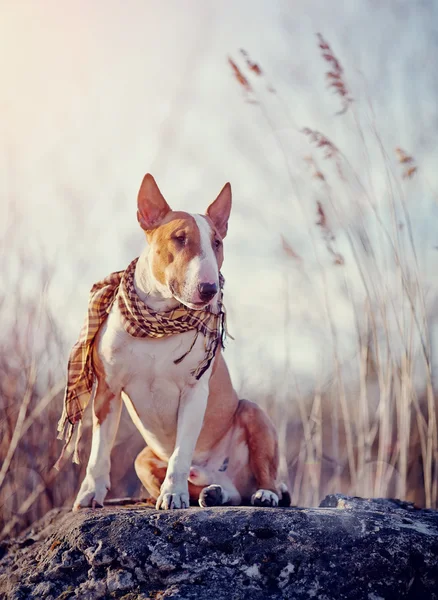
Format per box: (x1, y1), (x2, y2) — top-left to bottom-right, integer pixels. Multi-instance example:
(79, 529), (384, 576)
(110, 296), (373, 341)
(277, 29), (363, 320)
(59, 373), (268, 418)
(75, 304), (253, 508)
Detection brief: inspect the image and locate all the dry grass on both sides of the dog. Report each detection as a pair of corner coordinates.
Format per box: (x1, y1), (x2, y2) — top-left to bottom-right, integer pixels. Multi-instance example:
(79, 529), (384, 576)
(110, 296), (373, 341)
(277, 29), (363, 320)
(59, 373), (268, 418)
(0, 36), (438, 539)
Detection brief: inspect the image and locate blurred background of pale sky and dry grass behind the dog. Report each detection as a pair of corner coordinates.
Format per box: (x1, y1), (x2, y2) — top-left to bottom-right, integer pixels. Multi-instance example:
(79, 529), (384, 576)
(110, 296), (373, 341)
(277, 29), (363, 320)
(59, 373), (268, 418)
(0, 0), (438, 538)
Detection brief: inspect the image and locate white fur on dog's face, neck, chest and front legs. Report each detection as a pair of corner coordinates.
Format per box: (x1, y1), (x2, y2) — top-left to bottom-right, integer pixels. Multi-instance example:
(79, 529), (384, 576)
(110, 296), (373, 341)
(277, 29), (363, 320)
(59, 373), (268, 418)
(74, 216), (219, 509)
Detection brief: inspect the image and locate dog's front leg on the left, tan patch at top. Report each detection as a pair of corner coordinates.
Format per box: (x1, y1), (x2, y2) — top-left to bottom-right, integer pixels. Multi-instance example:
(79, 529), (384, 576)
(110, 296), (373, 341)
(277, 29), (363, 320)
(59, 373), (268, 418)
(73, 381), (122, 510)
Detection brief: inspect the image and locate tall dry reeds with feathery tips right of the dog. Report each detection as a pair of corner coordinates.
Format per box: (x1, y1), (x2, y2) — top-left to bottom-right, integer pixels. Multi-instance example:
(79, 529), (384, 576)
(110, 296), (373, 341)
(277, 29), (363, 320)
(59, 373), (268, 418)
(229, 34), (438, 507)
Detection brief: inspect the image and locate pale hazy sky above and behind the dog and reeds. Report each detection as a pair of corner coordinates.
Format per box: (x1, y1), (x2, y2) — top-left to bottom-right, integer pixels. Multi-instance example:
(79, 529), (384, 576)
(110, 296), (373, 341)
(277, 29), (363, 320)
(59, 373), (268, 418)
(0, 0), (438, 396)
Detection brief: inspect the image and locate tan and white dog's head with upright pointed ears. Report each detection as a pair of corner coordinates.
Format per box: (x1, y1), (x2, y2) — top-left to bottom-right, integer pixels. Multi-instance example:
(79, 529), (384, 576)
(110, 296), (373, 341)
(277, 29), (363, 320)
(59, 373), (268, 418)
(137, 174), (231, 309)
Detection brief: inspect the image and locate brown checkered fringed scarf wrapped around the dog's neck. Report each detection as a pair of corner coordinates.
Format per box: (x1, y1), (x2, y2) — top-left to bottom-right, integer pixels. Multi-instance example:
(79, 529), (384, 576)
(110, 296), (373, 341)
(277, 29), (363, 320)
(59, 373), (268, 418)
(56, 258), (226, 467)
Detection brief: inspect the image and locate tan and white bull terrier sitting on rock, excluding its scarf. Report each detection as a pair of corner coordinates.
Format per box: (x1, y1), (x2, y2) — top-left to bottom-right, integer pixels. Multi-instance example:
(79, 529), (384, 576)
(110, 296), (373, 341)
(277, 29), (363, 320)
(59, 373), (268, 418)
(73, 174), (290, 510)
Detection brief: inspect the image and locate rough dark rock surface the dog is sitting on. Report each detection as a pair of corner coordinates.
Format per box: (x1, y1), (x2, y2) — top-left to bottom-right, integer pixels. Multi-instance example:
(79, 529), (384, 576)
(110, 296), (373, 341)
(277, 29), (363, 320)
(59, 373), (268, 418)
(0, 496), (438, 600)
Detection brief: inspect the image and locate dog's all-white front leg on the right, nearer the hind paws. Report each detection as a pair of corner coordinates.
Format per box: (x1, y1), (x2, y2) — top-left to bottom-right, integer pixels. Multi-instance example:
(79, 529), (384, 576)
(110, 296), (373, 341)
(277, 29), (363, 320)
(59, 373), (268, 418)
(156, 372), (210, 510)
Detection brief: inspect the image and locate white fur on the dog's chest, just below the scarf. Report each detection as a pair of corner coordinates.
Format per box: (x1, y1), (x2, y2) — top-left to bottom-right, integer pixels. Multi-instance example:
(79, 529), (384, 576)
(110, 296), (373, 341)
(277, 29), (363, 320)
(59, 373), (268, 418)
(98, 306), (214, 460)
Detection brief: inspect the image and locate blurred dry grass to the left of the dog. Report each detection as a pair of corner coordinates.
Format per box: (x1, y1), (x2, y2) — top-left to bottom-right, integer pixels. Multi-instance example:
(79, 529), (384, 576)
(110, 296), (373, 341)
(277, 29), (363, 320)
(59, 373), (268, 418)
(0, 198), (141, 540)
